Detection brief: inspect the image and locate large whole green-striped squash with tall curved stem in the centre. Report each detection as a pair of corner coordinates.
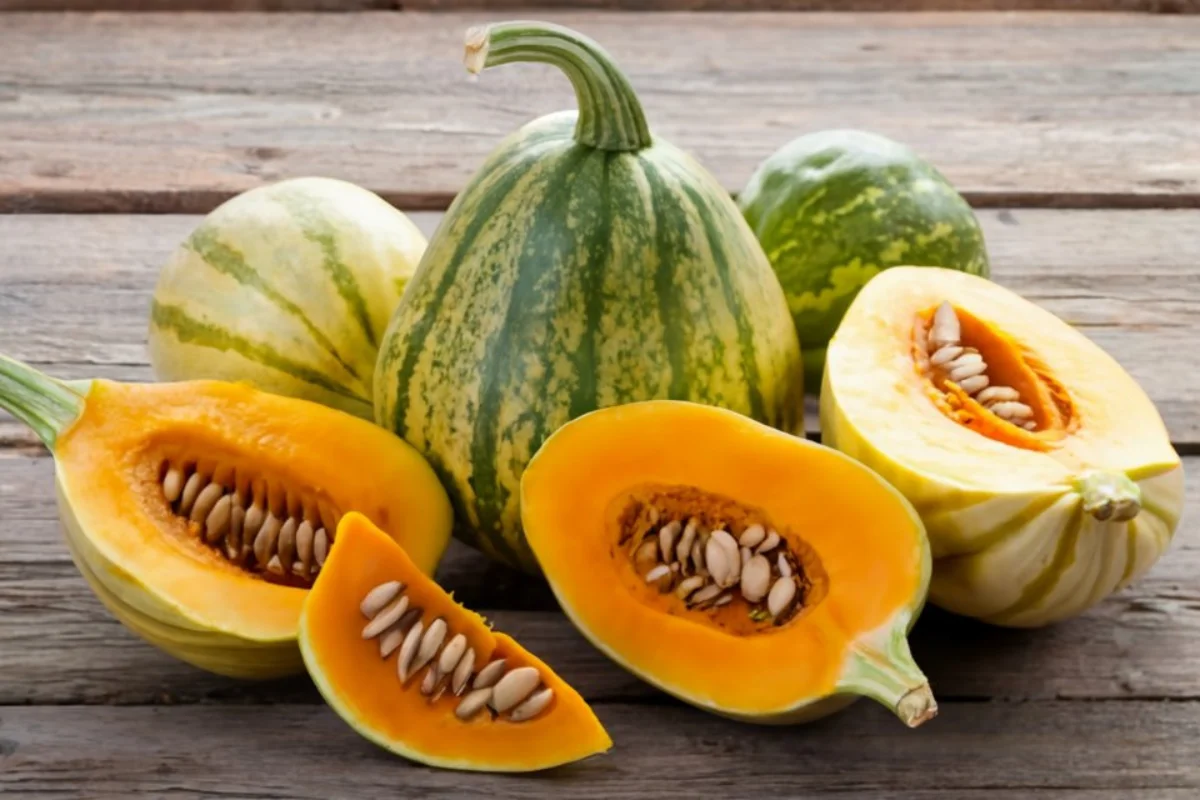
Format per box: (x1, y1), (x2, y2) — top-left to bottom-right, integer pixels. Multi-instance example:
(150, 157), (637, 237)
(376, 23), (803, 572)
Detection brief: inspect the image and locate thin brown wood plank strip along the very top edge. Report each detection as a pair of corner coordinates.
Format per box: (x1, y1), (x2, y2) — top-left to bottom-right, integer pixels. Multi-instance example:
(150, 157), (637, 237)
(0, 0), (1200, 13)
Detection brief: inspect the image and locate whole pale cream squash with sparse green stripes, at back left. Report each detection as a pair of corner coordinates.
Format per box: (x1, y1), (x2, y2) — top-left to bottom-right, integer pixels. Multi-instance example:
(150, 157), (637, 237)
(150, 178), (425, 419)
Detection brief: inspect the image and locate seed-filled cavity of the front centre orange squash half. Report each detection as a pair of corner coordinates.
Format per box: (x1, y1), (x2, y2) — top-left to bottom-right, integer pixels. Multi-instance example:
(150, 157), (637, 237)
(610, 486), (828, 636)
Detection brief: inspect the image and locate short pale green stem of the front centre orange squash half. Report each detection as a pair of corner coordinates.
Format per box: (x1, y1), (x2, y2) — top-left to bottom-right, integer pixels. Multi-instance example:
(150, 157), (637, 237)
(838, 614), (937, 728)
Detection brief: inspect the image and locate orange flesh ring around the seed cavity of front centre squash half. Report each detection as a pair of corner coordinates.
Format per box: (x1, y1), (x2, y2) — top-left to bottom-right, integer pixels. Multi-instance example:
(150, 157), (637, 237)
(521, 401), (929, 722)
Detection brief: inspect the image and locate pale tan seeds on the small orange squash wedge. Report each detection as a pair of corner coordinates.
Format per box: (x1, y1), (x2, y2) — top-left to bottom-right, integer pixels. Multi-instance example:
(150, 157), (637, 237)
(359, 581), (554, 722)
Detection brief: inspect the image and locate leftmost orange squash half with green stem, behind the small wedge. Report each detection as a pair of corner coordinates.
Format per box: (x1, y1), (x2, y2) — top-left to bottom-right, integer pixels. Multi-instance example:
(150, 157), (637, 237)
(0, 356), (451, 678)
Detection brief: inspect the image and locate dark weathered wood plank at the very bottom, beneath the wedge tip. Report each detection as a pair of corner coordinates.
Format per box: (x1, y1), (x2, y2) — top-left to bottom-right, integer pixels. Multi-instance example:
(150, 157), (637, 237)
(0, 703), (1200, 800)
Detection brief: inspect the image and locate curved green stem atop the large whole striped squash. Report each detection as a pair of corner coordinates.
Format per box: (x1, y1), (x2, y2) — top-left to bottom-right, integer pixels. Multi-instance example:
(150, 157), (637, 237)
(464, 22), (652, 152)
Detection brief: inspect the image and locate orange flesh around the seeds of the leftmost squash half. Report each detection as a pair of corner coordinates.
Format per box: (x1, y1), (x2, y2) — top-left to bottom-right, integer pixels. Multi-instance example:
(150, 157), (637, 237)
(55, 380), (451, 647)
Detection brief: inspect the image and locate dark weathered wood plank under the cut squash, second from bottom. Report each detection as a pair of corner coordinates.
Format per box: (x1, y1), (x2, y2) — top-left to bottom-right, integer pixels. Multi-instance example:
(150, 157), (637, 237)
(0, 453), (1200, 705)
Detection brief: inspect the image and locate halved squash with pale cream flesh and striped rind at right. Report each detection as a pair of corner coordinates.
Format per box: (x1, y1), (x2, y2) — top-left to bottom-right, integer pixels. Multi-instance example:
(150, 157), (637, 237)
(821, 267), (1183, 627)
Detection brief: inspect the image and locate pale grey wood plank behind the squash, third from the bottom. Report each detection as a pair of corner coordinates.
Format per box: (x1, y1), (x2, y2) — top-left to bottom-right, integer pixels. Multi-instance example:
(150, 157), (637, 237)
(0, 209), (1200, 445)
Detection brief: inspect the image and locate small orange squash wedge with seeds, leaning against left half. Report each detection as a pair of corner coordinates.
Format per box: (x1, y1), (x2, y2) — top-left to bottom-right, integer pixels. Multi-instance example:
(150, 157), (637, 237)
(300, 513), (612, 772)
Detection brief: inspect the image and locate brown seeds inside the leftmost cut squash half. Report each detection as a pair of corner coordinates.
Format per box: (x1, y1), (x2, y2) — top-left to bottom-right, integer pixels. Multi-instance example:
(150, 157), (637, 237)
(162, 464), (340, 584)
